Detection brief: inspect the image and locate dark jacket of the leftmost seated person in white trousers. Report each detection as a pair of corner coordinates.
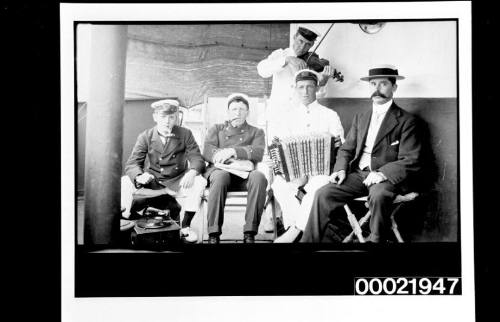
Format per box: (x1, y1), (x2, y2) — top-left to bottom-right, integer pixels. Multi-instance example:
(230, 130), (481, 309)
(125, 126), (205, 190)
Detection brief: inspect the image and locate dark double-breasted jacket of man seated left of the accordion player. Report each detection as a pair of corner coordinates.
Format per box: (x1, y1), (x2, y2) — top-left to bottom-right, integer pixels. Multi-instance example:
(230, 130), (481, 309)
(203, 121), (266, 177)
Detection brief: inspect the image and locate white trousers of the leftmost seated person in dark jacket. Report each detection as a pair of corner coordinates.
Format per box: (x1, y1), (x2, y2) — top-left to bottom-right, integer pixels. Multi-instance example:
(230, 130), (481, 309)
(121, 175), (207, 218)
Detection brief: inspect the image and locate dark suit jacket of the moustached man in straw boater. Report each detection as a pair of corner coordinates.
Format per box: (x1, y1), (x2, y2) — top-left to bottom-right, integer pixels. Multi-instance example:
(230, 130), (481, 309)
(334, 103), (422, 191)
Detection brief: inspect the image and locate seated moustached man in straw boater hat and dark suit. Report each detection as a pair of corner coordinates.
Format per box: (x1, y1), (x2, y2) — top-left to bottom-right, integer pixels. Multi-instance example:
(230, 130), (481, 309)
(300, 65), (421, 243)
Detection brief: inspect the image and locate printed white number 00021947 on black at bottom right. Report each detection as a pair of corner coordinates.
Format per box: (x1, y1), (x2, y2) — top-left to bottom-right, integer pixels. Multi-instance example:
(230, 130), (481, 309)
(354, 277), (462, 295)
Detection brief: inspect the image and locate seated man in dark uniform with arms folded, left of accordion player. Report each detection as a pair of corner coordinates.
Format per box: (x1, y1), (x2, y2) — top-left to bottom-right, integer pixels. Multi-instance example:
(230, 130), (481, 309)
(203, 93), (267, 244)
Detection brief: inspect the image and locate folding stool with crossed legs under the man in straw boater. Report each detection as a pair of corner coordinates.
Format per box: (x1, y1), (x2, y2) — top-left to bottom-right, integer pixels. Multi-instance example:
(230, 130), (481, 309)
(343, 192), (419, 243)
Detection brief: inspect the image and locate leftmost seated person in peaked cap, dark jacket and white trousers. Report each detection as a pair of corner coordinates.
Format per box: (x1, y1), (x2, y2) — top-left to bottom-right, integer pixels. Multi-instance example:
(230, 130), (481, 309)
(122, 99), (207, 242)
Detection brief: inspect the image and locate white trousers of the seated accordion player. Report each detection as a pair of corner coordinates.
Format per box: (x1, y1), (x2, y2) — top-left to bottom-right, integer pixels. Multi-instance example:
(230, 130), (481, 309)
(271, 175), (329, 231)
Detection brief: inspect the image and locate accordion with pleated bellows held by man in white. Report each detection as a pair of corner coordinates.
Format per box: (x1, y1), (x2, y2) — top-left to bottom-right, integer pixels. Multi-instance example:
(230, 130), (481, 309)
(268, 133), (337, 182)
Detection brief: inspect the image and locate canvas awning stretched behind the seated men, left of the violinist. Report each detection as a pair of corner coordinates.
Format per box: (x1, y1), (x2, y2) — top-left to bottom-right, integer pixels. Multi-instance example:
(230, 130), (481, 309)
(125, 24), (290, 107)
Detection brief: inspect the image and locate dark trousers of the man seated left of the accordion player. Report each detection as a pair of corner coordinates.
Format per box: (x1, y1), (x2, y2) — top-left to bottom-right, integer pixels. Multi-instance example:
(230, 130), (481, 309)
(207, 169), (267, 234)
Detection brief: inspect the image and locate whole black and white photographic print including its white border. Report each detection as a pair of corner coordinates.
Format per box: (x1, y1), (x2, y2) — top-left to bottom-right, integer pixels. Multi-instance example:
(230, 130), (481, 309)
(60, 2), (475, 321)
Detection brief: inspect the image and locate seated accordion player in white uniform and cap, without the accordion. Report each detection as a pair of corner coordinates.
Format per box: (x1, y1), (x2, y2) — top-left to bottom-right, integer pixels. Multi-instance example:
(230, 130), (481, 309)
(269, 69), (344, 243)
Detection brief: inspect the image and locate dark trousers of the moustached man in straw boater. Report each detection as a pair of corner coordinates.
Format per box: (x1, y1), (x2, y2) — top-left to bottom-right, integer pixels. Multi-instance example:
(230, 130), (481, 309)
(300, 170), (398, 243)
